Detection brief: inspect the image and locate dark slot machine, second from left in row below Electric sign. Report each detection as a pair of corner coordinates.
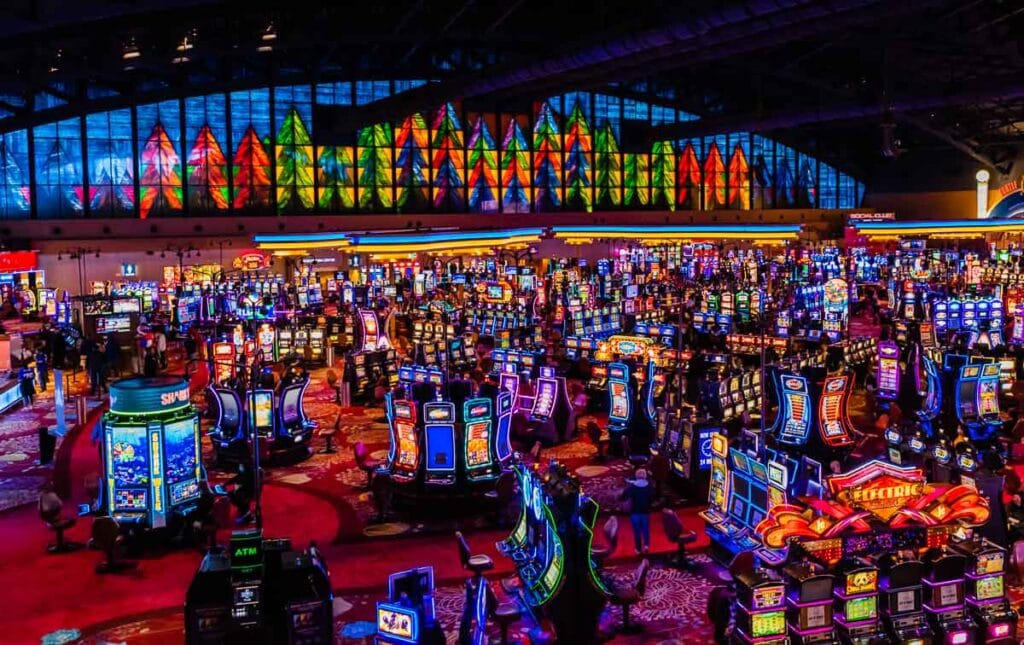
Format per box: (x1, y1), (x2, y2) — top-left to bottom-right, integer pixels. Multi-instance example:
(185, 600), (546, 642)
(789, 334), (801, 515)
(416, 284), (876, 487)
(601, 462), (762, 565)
(782, 560), (838, 645)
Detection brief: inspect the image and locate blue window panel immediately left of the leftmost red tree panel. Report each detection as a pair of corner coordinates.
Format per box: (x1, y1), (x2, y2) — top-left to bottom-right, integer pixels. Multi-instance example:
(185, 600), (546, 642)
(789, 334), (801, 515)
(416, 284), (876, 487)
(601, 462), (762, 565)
(85, 110), (135, 217)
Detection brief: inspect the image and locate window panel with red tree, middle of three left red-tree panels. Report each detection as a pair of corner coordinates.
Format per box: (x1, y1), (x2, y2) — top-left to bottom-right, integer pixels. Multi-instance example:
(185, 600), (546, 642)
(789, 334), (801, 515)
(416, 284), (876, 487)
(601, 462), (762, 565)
(185, 94), (230, 215)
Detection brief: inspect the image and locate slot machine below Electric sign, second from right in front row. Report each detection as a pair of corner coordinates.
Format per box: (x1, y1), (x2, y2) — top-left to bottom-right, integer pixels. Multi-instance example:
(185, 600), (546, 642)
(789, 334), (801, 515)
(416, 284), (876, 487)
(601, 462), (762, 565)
(922, 547), (978, 645)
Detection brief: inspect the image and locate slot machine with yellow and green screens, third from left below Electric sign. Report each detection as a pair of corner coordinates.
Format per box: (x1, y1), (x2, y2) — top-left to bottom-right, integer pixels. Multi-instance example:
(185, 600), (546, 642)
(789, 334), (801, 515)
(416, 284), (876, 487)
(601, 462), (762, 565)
(833, 558), (882, 645)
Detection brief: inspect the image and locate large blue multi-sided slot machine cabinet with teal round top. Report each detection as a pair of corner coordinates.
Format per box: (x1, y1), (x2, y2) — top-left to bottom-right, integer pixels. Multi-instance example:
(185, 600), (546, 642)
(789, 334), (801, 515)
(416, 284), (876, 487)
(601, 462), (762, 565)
(100, 377), (205, 529)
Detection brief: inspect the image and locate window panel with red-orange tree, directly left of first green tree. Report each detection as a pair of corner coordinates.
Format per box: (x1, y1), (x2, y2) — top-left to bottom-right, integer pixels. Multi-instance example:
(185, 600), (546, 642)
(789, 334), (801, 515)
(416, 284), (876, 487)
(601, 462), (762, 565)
(231, 89), (272, 211)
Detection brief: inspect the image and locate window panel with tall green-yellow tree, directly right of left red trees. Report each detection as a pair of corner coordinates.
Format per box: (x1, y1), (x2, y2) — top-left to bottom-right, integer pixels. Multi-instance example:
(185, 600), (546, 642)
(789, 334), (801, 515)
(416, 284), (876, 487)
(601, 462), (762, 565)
(273, 85), (315, 214)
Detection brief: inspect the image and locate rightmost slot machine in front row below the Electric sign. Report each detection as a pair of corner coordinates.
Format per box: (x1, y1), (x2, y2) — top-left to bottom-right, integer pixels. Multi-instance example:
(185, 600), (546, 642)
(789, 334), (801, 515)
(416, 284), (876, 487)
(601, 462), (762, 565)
(949, 534), (1017, 645)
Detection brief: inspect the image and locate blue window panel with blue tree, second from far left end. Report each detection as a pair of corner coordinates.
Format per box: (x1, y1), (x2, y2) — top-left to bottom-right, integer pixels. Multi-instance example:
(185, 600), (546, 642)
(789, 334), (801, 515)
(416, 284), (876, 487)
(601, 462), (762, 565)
(33, 119), (84, 218)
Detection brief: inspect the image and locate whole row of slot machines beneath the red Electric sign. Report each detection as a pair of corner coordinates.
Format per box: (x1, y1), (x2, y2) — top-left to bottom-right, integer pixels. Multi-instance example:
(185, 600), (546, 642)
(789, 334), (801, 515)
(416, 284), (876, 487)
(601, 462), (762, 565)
(735, 528), (1017, 645)
